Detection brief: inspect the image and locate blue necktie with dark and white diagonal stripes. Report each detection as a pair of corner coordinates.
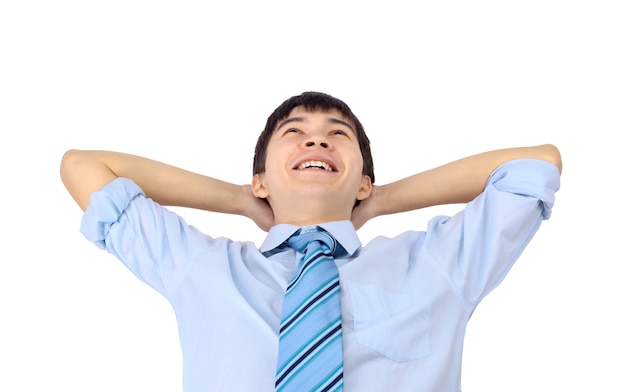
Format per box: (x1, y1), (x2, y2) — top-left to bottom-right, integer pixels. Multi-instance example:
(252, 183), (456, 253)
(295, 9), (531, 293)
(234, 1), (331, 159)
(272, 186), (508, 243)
(276, 227), (343, 392)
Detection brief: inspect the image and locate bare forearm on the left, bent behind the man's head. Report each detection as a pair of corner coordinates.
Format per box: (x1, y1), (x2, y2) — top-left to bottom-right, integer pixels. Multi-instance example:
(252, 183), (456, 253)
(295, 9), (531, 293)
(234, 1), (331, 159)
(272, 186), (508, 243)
(61, 150), (274, 230)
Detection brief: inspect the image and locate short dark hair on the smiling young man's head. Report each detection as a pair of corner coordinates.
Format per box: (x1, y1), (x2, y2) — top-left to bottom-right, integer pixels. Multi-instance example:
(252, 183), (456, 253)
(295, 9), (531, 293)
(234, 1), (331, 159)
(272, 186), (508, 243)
(252, 91), (374, 183)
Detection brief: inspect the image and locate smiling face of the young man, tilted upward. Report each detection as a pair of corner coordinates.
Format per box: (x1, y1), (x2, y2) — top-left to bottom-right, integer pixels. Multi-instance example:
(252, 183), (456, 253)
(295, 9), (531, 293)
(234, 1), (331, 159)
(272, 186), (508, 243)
(253, 107), (371, 219)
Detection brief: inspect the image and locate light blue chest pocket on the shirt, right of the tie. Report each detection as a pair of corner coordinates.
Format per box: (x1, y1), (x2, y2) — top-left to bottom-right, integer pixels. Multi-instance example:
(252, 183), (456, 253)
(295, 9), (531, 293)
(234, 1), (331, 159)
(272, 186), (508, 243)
(349, 283), (430, 362)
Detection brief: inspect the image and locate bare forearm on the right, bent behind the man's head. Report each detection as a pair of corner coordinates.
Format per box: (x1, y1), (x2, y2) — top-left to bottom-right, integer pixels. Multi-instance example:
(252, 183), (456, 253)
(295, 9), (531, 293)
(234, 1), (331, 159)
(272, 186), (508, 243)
(352, 144), (562, 229)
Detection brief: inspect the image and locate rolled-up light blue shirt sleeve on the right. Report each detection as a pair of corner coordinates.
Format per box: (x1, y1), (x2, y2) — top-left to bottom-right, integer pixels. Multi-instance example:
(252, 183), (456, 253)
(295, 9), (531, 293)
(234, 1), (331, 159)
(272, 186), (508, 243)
(424, 159), (560, 311)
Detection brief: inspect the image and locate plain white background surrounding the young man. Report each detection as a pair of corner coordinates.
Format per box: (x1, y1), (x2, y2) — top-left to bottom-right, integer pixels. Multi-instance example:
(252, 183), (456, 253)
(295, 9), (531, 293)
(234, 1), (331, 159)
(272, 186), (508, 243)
(0, 0), (626, 392)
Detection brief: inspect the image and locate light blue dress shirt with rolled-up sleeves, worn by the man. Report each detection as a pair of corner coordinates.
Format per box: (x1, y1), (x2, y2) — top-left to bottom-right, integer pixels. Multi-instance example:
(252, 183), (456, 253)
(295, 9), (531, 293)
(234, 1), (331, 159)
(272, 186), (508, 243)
(81, 159), (560, 392)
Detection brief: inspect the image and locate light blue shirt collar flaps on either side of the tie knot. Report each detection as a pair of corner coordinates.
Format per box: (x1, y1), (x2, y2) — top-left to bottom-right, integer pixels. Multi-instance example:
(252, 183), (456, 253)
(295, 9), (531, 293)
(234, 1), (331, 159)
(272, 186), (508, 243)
(259, 220), (361, 256)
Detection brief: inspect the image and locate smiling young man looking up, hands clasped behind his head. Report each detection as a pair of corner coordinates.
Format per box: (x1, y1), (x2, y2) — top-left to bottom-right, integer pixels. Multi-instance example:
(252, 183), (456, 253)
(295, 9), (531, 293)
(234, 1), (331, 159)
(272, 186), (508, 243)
(61, 92), (561, 392)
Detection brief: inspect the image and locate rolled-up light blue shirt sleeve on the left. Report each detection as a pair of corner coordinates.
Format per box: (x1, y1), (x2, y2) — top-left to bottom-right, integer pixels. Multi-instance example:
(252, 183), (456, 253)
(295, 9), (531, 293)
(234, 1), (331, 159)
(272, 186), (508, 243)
(80, 178), (211, 295)
